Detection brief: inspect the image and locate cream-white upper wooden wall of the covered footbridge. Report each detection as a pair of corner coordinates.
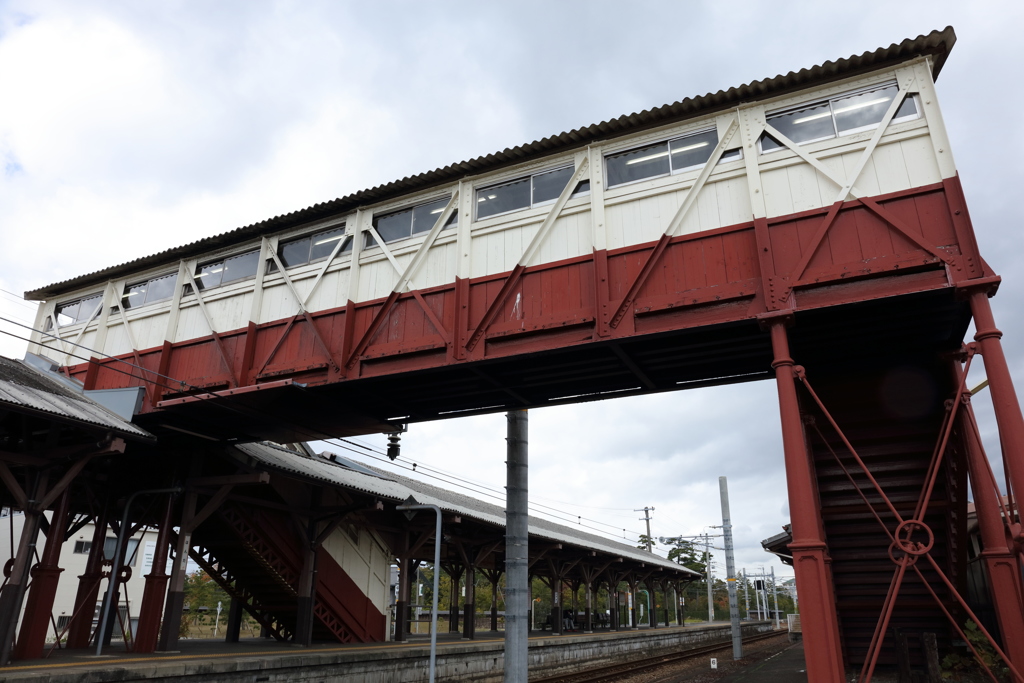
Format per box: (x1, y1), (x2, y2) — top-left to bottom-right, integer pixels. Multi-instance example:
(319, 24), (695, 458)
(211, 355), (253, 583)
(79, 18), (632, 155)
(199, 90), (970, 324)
(36, 59), (955, 360)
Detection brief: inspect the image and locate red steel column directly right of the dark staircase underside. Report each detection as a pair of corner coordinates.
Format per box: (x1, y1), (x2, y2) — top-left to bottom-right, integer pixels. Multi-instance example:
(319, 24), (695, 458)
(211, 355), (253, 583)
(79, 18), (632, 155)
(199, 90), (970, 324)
(961, 407), (1024, 669)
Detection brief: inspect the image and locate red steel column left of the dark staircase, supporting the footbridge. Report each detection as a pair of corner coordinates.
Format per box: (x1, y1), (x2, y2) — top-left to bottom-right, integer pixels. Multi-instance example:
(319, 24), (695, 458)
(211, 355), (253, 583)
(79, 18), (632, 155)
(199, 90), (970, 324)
(771, 321), (846, 683)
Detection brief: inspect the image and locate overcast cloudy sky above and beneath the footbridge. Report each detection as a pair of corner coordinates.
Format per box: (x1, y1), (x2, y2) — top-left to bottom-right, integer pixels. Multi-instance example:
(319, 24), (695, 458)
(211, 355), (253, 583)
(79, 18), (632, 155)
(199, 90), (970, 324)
(0, 0), (1024, 574)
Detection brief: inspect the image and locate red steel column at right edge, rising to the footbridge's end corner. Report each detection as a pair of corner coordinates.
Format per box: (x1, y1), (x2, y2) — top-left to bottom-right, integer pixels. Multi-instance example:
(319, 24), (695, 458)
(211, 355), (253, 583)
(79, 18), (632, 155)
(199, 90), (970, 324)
(971, 290), (1024, 543)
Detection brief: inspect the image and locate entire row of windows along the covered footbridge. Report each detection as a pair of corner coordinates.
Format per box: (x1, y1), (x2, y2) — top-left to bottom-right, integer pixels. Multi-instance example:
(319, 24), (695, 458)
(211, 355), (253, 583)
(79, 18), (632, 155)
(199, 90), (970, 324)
(47, 83), (920, 317)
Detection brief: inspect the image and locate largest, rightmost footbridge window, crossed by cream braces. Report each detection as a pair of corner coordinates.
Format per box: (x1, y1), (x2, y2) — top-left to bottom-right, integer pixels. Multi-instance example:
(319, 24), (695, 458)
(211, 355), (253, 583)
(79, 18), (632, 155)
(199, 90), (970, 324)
(760, 83), (920, 154)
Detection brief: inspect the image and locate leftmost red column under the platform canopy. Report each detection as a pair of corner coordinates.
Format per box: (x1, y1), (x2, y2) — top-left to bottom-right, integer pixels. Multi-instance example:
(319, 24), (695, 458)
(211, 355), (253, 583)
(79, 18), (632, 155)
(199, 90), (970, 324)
(12, 488), (71, 659)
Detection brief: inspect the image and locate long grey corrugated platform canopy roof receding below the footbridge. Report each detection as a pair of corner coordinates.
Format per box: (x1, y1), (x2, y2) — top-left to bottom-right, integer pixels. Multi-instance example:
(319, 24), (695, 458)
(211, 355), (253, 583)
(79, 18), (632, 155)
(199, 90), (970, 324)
(234, 442), (696, 575)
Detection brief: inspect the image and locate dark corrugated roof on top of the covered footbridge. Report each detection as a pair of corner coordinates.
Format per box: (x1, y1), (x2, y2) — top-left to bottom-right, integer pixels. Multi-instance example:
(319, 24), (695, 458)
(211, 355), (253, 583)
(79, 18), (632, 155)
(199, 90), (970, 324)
(25, 27), (956, 300)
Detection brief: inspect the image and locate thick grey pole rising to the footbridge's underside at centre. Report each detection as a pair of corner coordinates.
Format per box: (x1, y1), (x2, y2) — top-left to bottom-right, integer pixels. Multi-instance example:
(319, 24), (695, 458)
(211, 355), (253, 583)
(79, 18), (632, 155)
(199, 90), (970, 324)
(504, 411), (531, 683)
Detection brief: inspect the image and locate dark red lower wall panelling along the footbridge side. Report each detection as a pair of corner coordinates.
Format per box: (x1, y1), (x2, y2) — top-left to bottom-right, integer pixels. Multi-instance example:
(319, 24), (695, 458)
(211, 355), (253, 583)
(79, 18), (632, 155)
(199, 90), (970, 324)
(58, 185), (970, 413)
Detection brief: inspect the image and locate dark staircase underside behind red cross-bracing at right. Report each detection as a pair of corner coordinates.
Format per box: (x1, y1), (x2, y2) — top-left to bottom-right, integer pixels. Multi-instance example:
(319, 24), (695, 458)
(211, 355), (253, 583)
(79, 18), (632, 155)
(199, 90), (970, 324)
(801, 362), (968, 670)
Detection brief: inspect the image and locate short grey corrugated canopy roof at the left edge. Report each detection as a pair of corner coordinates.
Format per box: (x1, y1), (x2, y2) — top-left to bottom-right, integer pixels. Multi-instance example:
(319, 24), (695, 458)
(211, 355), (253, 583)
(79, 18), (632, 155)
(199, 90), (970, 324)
(0, 356), (155, 441)
